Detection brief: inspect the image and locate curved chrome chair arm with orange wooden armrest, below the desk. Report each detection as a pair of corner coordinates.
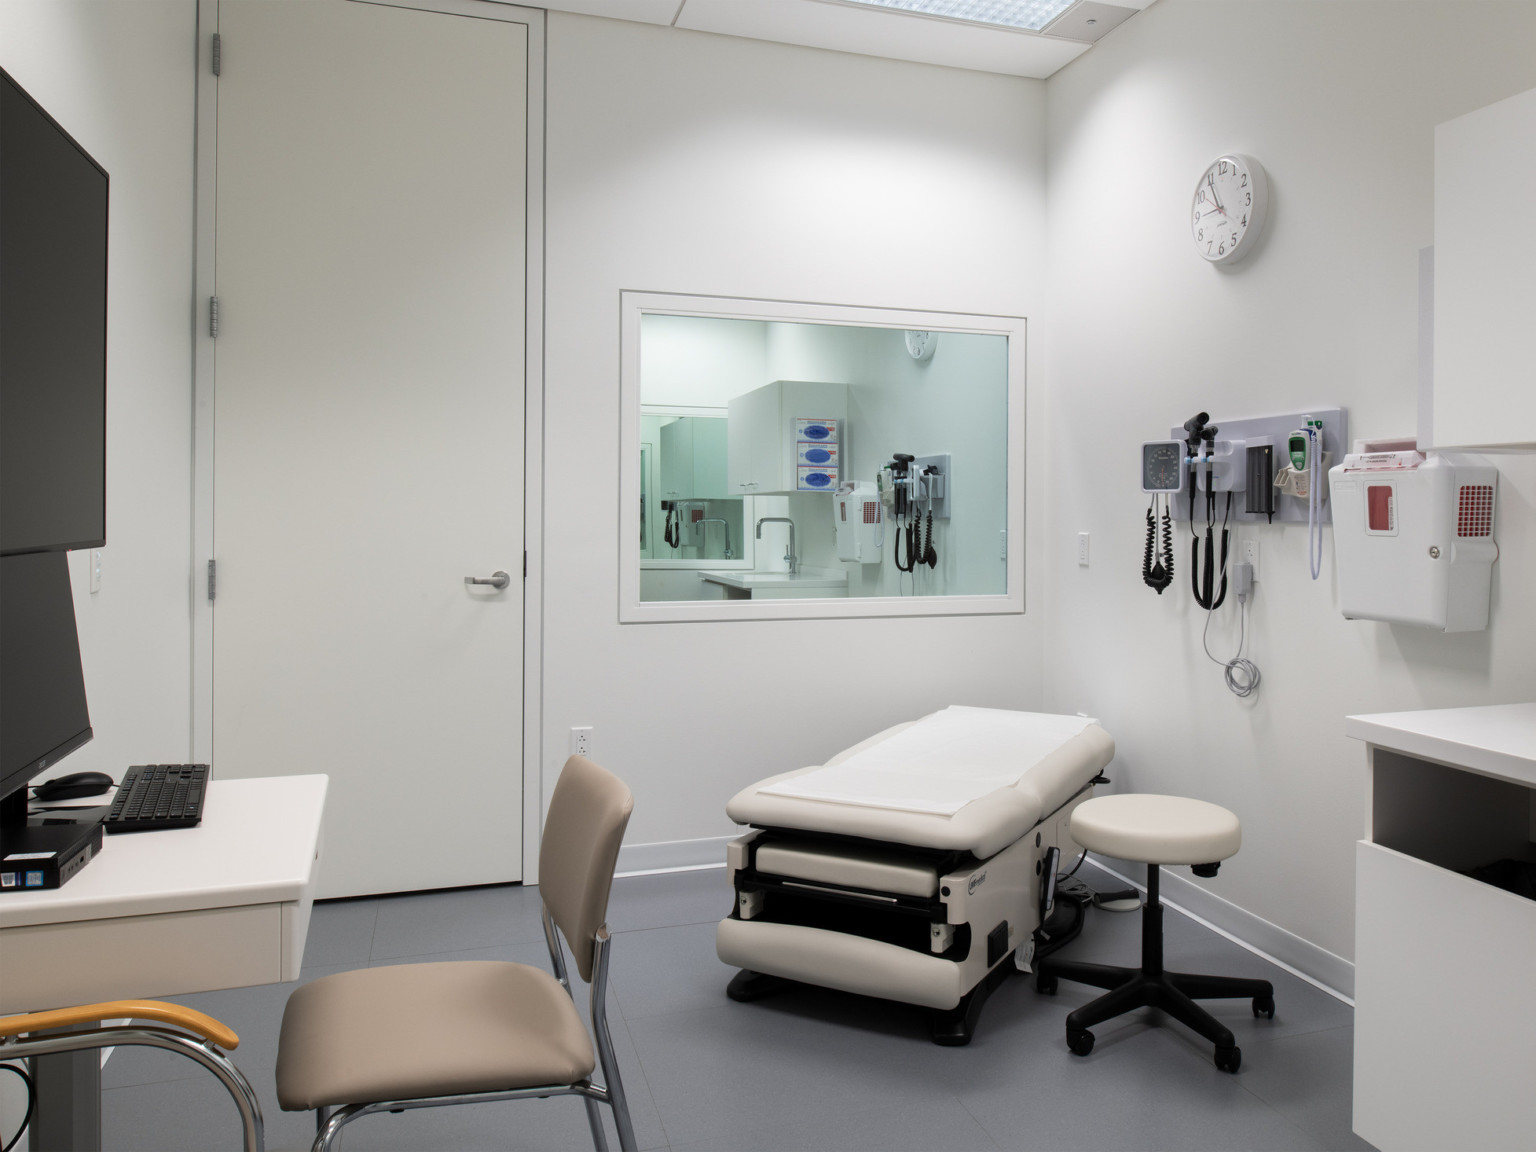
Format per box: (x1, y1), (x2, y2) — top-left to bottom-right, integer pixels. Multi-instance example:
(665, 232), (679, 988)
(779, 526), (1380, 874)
(0, 1000), (266, 1152)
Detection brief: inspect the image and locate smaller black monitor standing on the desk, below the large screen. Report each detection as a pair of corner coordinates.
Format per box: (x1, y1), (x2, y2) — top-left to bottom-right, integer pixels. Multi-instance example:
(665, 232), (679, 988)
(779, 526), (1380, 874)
(0, 551), (91, 828)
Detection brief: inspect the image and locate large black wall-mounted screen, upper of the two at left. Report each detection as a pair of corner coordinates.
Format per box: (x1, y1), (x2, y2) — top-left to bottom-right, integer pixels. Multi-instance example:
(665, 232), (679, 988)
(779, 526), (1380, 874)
(0, 69), (108, 556)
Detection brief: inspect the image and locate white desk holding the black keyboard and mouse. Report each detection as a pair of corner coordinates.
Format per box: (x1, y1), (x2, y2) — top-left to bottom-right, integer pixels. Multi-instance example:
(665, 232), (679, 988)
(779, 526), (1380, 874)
(0, 776), (329, 1152)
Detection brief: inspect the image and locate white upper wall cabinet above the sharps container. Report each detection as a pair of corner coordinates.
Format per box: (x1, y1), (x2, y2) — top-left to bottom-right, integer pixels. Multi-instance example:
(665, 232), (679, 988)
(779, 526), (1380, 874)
(1419, 89), (1536, 450)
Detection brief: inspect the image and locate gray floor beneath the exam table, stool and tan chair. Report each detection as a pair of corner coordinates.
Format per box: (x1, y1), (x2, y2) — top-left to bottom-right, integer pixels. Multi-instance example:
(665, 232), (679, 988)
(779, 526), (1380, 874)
(103, 871), (1364, 1152)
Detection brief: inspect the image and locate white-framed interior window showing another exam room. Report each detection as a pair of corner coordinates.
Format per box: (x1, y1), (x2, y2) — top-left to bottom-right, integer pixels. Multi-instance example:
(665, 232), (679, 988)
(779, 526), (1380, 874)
(621, 293), (1023, 622)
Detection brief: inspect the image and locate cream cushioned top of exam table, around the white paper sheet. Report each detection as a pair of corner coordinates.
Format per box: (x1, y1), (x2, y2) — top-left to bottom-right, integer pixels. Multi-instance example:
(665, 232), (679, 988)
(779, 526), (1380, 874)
(725, 708), (1115, 859)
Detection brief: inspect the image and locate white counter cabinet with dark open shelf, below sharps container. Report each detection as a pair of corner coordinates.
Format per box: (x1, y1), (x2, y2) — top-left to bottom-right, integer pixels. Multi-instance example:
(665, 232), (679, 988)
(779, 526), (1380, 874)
(1344, 703), (1536, 1152)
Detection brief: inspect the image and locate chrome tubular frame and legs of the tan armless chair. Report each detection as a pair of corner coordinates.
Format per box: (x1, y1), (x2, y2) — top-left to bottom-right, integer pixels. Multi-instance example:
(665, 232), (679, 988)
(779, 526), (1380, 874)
(312, 905), (636, 1152)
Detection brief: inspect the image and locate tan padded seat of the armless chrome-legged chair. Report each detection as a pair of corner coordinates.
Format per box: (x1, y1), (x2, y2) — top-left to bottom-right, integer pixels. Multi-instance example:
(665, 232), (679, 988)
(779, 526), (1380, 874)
(276, 960), (596, 1112)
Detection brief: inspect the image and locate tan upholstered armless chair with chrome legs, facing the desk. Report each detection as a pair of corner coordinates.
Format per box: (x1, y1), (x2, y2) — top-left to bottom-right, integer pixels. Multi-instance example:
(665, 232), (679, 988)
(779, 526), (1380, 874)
(276, 756), (634, 1152)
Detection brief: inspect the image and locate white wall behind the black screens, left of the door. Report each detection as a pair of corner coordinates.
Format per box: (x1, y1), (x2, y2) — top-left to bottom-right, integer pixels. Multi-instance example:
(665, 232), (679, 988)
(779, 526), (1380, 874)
(0, 0), (197, 777)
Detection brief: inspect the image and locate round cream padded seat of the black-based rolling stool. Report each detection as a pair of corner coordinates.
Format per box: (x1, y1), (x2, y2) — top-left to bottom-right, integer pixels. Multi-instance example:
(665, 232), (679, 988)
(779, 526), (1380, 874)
(1072, 793), (1243, 865)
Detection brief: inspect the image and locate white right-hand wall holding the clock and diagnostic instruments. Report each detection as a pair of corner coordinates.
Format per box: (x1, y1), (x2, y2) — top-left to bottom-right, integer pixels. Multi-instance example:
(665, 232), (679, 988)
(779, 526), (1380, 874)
(1037, 0), (1536, 957)
